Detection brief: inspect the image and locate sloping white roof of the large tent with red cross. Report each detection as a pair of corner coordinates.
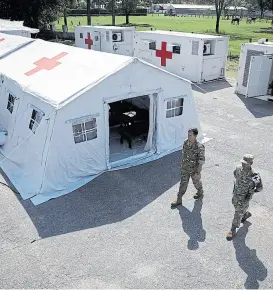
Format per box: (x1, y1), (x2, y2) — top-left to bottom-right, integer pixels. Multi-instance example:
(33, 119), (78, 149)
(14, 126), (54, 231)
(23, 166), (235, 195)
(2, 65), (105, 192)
(0, 40), (133, 107)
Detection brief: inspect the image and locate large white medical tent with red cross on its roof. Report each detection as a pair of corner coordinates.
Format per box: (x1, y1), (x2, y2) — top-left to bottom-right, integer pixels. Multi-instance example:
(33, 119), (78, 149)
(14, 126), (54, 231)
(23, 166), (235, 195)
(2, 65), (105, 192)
(0, 35), (202, 204)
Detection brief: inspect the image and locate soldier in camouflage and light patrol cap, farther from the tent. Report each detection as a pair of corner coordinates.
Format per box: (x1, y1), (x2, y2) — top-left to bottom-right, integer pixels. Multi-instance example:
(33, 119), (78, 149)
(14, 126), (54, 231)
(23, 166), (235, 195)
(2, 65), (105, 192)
(227, 154), (263, 240)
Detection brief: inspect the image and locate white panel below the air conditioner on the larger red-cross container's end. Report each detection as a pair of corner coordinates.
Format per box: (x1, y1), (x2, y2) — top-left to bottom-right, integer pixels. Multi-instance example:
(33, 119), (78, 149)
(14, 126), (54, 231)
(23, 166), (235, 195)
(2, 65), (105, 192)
(202, 57), (223, 82)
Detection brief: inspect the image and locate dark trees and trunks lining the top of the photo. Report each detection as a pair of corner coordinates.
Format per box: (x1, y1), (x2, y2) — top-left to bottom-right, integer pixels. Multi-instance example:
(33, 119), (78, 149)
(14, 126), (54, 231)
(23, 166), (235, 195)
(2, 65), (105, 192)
(0, 0), (273, 33)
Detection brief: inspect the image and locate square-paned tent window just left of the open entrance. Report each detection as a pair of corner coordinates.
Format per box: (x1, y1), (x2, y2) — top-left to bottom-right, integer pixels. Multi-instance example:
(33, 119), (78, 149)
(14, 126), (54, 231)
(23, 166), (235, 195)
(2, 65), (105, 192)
(72, 118), (97, 144)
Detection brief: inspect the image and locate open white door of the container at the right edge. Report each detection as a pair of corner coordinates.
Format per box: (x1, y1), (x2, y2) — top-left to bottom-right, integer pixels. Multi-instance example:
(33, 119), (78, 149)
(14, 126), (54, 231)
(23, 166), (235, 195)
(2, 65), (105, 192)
(246, 55), (272, 98)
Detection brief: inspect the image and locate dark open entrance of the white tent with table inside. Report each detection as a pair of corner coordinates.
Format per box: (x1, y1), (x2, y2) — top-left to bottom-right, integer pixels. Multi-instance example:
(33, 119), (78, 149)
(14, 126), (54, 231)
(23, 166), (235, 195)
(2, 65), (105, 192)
(109, 95), (152, 163)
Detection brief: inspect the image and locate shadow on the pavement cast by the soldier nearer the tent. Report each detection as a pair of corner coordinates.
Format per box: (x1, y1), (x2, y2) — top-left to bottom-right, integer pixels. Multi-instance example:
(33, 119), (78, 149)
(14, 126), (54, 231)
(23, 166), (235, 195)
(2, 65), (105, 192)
(175, 200), (206, 250)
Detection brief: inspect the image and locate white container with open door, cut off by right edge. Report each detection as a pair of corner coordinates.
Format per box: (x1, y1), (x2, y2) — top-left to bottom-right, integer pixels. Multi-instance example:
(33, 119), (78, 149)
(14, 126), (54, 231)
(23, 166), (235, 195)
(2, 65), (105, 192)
(235, 39), (273, 101)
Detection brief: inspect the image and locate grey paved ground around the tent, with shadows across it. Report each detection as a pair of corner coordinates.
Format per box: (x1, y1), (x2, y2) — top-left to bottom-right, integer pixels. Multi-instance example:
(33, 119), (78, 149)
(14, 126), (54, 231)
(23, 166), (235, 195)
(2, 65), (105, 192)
(0, 78), (273, 289)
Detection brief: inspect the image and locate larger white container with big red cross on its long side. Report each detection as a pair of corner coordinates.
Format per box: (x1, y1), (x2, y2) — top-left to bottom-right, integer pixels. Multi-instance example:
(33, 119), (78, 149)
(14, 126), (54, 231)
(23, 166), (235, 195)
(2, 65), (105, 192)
(134, 31), (229, 83)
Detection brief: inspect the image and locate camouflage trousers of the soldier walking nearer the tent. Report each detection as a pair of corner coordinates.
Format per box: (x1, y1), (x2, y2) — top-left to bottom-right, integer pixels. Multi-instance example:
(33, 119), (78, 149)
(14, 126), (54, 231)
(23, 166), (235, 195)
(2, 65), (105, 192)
(177, 171), (203, 201)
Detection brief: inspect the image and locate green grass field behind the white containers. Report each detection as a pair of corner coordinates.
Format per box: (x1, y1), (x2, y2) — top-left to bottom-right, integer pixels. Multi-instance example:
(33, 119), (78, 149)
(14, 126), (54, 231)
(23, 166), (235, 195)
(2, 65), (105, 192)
(56, 15), (273, 76)
